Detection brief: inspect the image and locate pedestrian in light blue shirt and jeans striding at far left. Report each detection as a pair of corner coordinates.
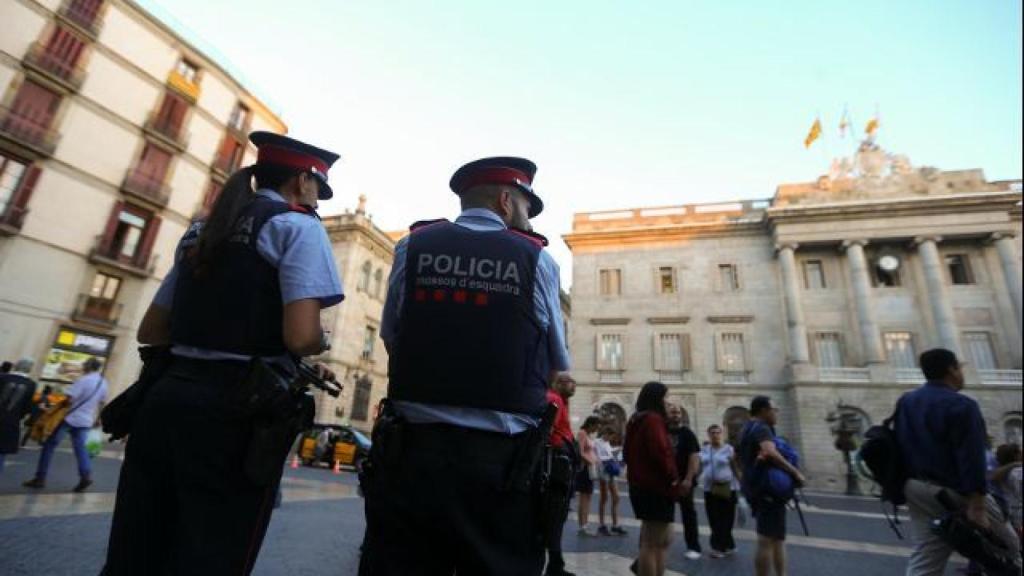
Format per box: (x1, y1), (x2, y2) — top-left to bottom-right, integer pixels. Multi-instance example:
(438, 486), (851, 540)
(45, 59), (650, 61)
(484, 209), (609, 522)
(22, 357), (108, 492)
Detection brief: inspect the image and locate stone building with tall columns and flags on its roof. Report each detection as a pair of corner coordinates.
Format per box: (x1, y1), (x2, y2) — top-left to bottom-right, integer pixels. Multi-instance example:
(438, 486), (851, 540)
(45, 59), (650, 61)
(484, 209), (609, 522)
(564, 142), (1022, 489)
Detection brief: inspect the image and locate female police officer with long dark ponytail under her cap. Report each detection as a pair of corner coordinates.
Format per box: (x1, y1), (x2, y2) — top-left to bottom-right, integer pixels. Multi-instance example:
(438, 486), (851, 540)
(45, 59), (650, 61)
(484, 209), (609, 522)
(103, 132), (344, 576)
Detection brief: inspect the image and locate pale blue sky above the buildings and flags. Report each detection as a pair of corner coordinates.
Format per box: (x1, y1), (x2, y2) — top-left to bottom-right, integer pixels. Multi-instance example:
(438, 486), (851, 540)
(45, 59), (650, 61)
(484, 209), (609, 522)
(142, 0), (1022, 284)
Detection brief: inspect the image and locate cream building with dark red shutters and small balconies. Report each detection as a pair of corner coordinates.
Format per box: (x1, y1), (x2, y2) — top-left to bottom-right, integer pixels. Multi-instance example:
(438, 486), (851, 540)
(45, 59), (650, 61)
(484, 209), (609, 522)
(0, 0), (286, 394)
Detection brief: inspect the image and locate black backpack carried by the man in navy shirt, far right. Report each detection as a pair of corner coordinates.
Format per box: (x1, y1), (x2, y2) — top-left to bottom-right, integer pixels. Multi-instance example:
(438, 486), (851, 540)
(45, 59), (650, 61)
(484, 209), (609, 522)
(859, 404), (908, 538)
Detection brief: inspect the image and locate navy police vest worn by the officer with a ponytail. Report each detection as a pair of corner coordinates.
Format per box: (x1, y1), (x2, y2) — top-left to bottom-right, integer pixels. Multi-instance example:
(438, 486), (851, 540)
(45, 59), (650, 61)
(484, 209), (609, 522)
(165, 196), (302, 357)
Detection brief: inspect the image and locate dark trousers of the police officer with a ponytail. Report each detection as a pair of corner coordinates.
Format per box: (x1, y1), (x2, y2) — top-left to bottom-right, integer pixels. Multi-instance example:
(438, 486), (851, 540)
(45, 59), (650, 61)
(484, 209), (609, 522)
(102, 360), (280, 576)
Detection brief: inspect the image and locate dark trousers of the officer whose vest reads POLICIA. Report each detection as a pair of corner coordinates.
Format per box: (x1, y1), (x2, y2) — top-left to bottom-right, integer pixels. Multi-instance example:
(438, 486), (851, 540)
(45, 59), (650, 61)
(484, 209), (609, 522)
(359, 421), (545, 576)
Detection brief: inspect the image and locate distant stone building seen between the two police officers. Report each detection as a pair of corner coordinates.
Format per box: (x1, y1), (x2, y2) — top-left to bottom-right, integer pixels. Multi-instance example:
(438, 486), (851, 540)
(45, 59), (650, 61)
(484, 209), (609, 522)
(316, 196), (400, 433)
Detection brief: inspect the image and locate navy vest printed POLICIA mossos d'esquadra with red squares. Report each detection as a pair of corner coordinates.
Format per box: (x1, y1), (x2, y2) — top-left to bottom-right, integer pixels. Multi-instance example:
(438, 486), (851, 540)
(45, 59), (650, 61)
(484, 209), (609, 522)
(388, 220), (550, 415)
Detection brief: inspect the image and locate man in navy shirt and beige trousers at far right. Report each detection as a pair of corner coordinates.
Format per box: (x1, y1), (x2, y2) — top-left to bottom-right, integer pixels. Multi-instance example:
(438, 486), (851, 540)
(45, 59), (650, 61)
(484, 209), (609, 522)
(895, 348), (1020, 576)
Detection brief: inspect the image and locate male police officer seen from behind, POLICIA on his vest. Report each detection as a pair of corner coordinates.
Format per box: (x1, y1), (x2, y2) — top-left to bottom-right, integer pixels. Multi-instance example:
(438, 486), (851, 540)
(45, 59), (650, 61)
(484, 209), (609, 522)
(359, 158), (568, 576)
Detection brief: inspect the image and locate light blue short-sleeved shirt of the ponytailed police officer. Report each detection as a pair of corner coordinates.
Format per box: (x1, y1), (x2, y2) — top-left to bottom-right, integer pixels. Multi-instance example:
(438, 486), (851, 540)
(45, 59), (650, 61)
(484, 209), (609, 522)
(153, 189), (345, 360)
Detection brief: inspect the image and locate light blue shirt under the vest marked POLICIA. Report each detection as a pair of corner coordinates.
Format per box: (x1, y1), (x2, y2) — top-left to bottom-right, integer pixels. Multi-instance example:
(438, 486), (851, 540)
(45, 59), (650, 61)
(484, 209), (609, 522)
(381, 208), (569, 435)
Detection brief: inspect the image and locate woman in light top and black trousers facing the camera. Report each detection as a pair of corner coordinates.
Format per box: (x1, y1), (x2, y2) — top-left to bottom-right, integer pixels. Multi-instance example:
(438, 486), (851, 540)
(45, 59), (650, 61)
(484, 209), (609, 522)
(700, 424), (740, 559)
